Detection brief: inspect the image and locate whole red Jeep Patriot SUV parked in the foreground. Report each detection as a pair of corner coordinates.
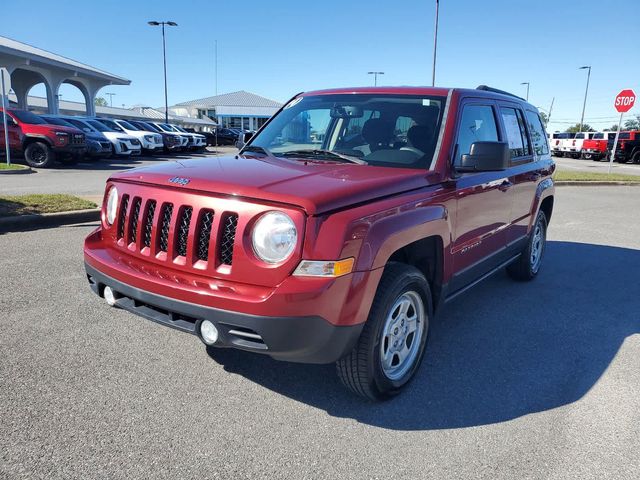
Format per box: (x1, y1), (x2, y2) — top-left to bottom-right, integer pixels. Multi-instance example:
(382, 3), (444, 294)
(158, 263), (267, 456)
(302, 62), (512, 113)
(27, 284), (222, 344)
(84, 86), (555, 399)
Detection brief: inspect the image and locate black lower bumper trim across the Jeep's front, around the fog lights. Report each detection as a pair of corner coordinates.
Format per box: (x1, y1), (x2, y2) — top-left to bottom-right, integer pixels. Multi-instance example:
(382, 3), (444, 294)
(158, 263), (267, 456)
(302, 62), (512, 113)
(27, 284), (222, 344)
(85, 262), (364, 364)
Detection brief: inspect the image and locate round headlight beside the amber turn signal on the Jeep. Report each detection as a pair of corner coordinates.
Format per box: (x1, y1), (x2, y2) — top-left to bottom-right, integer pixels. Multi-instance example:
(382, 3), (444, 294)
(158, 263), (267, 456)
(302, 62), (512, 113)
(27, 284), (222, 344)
(252, 212), (298, 263)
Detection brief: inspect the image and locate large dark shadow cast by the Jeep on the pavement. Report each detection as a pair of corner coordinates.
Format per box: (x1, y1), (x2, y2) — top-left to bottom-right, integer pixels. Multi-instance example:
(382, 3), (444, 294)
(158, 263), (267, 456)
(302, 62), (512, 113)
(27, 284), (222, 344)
(208, 242), (640, 430)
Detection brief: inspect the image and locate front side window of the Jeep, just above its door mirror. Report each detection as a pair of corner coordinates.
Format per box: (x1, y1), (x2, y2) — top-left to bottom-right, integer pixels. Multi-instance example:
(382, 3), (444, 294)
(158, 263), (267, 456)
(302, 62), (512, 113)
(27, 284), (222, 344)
(454, 105), (498, 165)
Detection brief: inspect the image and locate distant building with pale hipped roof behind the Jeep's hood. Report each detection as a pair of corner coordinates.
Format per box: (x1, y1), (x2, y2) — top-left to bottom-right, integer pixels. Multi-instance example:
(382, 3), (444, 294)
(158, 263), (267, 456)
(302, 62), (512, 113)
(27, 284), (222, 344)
(169, 90), (282, 130)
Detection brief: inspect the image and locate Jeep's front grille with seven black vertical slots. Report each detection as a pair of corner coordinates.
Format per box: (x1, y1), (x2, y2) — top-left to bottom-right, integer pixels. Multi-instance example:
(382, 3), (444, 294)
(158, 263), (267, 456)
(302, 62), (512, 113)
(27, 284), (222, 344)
(116, 198), (238, 268)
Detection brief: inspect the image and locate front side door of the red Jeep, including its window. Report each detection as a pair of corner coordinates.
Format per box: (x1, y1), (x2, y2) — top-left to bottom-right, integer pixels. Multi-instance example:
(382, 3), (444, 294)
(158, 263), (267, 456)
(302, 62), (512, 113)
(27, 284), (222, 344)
(450, 99), (512, 293)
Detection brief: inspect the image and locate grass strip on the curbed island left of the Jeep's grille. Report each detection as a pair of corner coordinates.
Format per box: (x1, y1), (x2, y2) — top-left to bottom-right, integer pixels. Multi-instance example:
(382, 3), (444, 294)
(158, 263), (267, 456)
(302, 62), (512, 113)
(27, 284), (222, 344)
(0, 193), (96, 218)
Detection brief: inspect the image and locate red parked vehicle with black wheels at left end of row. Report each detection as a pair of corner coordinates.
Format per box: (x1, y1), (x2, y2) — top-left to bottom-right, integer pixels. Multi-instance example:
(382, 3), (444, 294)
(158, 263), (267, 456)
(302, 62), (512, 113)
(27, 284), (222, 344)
(0, 108), (87, 168)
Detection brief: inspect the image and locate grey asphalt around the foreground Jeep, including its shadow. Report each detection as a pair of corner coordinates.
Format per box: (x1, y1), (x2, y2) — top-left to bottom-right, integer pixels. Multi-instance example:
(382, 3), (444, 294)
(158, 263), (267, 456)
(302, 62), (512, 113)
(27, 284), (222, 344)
(0, 187), (640, 480)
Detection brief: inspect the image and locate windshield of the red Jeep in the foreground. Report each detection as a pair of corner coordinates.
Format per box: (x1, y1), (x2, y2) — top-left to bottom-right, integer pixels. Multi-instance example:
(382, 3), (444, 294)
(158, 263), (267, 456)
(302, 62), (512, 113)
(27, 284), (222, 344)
(250, 94), (445, 168)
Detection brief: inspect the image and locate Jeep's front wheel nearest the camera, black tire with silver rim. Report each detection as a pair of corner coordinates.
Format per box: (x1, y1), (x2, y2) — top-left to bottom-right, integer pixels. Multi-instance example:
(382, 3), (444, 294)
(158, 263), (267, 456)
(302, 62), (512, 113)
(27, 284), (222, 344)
(336, 263), (433, 400)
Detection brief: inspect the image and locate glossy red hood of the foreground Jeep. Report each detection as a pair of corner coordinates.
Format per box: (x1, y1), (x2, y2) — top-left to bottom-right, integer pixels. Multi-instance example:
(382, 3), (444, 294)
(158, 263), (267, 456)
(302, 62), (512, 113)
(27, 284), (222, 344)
(111, 156), (438, 215)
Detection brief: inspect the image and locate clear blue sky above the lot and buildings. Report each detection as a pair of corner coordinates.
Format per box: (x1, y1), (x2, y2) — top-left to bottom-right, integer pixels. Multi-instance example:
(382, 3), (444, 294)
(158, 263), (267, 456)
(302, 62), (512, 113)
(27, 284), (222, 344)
(5, 0), (640, 130)
